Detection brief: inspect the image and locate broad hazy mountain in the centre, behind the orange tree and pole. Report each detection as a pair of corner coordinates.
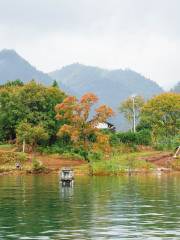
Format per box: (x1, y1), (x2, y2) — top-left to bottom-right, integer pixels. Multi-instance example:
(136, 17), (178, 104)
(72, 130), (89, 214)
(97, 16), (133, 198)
(49, 64), (163, 129)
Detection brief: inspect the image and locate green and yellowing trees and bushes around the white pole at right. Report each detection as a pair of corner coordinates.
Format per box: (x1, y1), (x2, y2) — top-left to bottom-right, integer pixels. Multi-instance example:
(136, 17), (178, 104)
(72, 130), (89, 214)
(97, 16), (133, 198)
(117, 92), (180, 150)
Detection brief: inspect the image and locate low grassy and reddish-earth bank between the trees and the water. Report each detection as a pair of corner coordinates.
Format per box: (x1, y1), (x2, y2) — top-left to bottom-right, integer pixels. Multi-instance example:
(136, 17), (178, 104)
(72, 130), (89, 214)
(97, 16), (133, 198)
(0, 146), (180, 176)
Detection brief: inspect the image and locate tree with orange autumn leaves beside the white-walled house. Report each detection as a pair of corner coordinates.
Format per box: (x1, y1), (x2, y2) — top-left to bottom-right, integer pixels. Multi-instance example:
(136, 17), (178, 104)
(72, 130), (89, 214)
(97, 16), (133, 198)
(55, 93), (114, 158)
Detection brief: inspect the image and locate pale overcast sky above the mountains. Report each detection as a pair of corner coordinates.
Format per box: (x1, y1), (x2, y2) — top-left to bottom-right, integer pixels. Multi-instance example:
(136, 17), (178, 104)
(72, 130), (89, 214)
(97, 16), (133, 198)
(0, 0), (180, 89)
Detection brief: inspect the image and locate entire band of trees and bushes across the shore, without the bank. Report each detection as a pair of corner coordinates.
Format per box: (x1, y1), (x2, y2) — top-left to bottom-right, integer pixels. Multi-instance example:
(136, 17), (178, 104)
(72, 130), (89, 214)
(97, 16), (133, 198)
(0, 80), (180, 159)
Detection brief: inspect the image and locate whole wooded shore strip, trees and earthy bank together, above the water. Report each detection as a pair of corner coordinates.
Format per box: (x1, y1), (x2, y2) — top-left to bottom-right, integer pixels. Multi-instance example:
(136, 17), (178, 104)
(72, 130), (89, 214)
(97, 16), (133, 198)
(0, 80), (180, 175)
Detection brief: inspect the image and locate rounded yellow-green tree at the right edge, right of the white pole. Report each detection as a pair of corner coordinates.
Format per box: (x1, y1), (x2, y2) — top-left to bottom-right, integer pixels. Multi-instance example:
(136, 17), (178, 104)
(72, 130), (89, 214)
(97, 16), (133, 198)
(141, 93), (180, 137)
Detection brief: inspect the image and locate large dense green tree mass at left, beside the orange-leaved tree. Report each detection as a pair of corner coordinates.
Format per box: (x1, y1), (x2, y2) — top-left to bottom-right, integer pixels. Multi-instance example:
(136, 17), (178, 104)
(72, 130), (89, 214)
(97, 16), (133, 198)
(0, 81), (65, 143)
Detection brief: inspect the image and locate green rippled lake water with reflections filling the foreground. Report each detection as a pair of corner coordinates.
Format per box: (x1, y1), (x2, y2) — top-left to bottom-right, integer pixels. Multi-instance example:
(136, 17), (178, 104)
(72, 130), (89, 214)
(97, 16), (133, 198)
(0, 175), (180, 240)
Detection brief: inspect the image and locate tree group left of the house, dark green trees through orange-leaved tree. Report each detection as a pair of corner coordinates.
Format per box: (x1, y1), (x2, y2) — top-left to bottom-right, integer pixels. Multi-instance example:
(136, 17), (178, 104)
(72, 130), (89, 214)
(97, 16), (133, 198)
(0, 80), (113, 159)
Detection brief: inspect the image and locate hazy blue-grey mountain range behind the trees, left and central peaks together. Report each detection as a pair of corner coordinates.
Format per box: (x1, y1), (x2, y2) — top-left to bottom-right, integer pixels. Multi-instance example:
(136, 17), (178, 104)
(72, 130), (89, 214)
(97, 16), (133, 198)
(0, 50), (166, 129)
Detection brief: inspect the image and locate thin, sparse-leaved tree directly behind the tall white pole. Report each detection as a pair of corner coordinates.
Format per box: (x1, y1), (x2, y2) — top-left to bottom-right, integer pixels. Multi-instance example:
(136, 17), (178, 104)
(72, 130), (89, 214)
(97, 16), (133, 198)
(119, 96), (145, 131)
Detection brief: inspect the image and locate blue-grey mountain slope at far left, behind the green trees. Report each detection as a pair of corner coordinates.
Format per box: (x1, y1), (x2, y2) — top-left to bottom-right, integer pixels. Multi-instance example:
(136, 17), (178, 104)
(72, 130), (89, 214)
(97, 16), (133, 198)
(0, 49), (52, 84)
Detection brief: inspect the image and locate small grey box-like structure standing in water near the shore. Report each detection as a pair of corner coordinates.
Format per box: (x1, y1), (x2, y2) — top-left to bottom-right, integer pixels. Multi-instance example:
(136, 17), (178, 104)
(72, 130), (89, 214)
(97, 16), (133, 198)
(60, 168), (74, 187)
